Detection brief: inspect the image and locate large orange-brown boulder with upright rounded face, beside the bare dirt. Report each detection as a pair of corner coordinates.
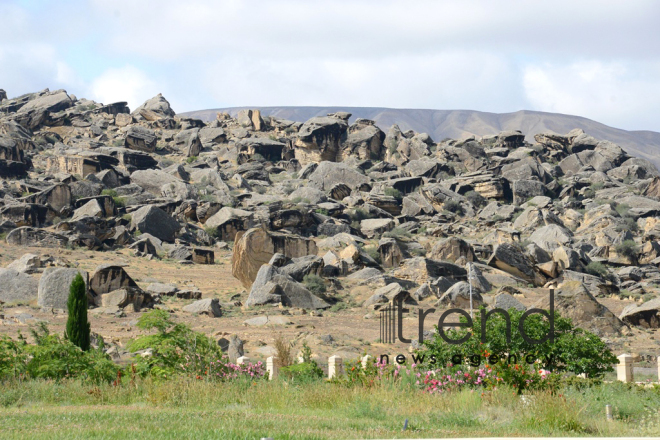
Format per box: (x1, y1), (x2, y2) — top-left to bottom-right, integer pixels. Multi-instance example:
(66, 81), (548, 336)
(231, 228), (318, 288)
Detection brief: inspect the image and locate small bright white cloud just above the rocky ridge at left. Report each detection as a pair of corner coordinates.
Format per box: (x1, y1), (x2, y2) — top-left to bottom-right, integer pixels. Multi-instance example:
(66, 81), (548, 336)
(89, 65), (159, 109)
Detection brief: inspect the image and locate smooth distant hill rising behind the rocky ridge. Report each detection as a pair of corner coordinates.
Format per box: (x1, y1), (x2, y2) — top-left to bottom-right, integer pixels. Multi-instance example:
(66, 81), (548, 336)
(181, 107), (660, 168)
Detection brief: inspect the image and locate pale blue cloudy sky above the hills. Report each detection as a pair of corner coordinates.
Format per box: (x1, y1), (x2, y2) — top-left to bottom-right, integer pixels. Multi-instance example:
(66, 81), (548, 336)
(0, 0), (660, 131)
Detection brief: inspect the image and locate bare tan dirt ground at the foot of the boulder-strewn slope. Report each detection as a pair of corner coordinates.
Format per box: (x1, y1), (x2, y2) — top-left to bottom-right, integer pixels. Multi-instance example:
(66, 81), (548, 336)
(0, 243), (660, 362)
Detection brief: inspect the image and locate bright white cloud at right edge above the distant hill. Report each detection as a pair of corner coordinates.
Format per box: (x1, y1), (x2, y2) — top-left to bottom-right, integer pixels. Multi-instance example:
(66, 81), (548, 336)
(523, 60), (660, 129)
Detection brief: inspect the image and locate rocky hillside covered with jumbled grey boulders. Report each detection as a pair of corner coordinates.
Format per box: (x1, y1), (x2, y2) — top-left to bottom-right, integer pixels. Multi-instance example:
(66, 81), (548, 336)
(0, 90), (660, 360)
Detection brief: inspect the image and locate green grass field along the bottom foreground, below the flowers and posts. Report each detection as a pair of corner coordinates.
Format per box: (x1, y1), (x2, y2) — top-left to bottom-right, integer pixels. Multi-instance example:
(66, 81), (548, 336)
(0, 379), (660, 440)
